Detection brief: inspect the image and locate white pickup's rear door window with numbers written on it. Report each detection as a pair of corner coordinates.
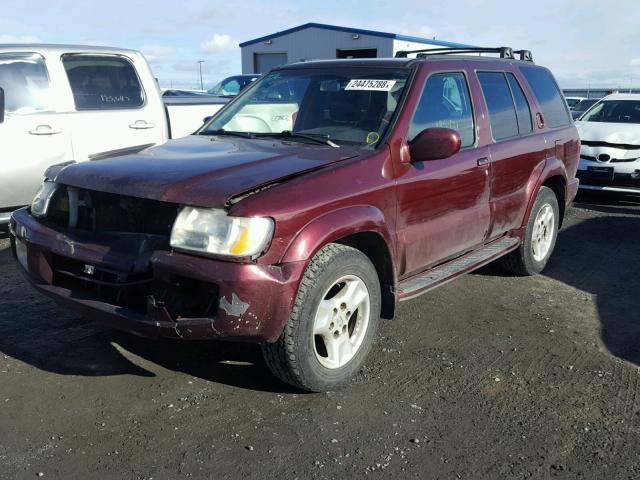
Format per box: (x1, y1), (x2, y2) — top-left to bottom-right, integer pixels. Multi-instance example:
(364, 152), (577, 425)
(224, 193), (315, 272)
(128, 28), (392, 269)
(62, 54), (144, 110)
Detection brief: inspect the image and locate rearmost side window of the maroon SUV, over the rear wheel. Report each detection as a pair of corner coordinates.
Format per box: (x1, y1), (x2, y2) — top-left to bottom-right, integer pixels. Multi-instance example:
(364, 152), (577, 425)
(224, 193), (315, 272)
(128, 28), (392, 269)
(520, 67), (571, 128)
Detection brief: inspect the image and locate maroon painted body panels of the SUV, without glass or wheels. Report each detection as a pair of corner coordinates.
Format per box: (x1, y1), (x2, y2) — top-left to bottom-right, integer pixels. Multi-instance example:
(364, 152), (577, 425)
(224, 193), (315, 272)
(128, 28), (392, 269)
(11, 58), (579, 341)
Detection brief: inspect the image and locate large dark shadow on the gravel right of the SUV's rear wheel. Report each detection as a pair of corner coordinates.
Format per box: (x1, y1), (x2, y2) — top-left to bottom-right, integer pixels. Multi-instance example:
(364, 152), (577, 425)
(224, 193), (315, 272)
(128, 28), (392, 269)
(478, 189), (640, 366)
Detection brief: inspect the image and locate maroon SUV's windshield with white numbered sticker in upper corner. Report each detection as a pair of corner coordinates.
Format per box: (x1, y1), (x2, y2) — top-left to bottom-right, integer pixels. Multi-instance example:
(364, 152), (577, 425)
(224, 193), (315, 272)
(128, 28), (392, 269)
(200, 67), (410, 148)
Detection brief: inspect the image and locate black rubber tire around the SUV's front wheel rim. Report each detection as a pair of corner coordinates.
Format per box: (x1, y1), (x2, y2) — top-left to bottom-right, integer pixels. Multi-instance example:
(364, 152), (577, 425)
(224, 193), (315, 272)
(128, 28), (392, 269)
(262, 243), (381, 392)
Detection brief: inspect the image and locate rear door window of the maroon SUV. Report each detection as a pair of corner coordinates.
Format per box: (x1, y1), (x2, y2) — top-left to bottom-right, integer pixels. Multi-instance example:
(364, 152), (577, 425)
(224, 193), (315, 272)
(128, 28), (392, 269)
(478, 72), (518, 140)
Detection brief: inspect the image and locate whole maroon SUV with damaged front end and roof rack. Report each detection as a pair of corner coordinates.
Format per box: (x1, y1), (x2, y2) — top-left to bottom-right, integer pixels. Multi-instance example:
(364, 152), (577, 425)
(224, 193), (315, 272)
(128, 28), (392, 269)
(11, 49), (579, 391)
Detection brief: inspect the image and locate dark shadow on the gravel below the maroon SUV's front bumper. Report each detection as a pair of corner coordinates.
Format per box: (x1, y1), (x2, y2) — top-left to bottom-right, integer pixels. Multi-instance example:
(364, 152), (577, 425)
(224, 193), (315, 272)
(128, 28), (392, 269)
(0, 242), (292, 392)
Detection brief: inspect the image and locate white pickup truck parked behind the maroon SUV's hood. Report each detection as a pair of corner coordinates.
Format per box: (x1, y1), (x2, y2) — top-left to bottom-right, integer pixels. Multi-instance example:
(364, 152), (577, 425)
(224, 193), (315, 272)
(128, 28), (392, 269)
(0, 44), (229, 228)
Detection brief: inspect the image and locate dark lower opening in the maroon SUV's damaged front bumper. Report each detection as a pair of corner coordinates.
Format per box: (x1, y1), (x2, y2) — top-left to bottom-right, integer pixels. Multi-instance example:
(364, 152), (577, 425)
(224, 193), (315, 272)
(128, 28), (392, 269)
(50, 255), (219, 321)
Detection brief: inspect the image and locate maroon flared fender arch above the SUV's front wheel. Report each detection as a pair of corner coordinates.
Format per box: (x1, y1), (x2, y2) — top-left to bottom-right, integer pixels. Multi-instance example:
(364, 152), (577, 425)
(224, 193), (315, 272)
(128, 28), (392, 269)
(282, 205), (395, 264)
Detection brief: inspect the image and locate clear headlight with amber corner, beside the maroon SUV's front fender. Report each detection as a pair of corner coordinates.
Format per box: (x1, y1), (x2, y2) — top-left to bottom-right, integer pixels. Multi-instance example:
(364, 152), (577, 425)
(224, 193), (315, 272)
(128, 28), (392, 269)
(171, 207), (273, 257)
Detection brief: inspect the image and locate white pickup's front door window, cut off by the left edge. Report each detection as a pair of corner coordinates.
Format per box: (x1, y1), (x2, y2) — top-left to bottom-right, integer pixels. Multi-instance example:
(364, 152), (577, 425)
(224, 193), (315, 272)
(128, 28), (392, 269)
(0, 53), (51, 114)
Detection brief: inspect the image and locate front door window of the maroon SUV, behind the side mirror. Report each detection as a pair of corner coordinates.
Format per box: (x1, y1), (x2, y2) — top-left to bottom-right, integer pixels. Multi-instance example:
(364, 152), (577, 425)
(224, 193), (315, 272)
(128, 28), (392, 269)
(409, 72), (475, 147)
